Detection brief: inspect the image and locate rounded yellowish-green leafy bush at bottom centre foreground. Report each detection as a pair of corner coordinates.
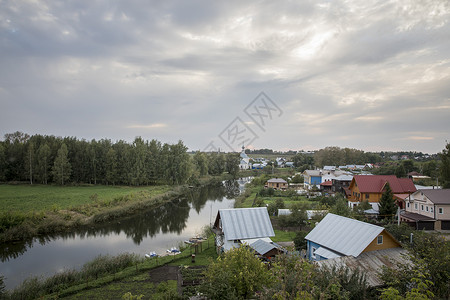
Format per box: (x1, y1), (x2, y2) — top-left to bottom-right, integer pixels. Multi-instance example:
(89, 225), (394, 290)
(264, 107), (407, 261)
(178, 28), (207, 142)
(201, 246), (272, 300)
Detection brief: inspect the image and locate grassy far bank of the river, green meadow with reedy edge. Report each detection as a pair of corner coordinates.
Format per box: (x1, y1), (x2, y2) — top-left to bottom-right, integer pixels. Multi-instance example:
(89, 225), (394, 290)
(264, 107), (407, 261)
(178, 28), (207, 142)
(0, 177), (220, 243)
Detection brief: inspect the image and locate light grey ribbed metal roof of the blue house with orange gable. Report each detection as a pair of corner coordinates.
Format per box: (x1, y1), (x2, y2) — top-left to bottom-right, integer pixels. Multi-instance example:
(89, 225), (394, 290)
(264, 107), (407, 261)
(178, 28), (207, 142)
(305, 213), (384, 257)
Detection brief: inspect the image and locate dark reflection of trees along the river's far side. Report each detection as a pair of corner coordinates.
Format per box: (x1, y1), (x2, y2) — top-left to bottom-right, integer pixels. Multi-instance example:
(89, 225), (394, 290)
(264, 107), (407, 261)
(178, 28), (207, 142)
(0, 181), (239, 262)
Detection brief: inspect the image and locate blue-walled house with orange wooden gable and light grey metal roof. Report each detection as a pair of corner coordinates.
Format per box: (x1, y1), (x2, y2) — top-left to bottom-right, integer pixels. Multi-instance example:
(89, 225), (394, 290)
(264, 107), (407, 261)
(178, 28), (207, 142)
(305, 213), (401, 261)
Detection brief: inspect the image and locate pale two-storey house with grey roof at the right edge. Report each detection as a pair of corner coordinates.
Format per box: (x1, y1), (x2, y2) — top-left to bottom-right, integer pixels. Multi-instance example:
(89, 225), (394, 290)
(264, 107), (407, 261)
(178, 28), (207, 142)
(400, 189), (450, 230)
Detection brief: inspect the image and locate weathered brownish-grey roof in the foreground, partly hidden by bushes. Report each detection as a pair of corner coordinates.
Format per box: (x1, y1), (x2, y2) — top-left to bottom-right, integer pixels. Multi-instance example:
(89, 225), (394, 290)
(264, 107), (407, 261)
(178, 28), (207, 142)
(316, 248), (409, 287)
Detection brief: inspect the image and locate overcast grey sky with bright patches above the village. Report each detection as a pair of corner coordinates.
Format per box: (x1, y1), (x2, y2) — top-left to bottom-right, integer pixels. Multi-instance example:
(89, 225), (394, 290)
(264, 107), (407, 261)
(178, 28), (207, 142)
(0, 0), (450, 154)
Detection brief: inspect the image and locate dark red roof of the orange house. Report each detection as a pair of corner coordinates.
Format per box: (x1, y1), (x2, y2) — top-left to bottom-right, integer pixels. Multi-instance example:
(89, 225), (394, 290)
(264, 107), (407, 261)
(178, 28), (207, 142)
(352, 175), (416, 194)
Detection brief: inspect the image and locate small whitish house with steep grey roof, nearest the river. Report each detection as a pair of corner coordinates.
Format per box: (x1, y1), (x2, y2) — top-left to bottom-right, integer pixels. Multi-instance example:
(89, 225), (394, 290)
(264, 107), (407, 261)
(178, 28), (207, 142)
(213, 207), (276, 253)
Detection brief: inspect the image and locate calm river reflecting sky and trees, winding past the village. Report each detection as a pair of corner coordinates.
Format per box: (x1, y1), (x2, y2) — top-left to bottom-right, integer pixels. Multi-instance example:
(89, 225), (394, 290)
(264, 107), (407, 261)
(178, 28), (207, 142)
(0, 178), (250, 289)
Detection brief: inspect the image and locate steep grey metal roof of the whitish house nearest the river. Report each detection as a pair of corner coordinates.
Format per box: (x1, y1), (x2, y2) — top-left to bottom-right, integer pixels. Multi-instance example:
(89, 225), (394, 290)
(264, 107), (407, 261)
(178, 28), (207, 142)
(219, 207), (275, 241)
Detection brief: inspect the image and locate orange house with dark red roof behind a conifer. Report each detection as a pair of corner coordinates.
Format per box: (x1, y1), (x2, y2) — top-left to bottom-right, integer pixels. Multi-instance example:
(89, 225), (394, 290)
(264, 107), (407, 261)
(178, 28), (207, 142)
(347, 175), (416, 211)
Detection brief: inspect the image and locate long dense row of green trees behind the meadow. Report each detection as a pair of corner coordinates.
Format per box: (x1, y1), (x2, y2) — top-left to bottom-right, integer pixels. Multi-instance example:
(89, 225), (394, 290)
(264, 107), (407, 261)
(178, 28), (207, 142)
(0, 132), (239, 186)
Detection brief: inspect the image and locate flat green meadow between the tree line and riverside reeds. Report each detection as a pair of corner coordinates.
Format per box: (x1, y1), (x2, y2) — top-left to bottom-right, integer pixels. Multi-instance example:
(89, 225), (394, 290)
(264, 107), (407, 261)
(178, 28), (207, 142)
(0, 184), (170, 213)
